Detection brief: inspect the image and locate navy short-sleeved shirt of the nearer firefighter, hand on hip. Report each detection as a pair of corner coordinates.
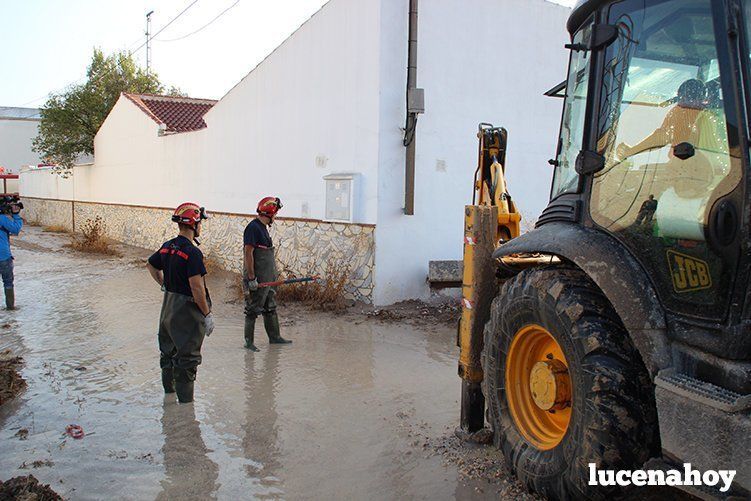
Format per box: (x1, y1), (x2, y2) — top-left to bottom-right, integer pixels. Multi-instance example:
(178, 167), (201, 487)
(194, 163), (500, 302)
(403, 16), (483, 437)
(149, 235), (206, 297)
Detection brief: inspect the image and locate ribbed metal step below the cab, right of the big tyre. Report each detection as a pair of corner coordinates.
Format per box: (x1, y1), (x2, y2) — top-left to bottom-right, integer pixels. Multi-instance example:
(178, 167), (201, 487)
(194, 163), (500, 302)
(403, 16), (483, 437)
(655, 369), (751, 412)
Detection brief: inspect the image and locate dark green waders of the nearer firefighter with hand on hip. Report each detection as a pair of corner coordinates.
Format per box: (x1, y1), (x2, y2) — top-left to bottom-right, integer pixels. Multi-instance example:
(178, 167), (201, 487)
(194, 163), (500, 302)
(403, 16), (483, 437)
(159, 292), (206, 403)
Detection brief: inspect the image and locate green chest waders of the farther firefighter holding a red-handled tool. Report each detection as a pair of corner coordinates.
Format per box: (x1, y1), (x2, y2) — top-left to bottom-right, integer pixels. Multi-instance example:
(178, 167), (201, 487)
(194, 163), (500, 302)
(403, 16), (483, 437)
(245, 248), (292, 351)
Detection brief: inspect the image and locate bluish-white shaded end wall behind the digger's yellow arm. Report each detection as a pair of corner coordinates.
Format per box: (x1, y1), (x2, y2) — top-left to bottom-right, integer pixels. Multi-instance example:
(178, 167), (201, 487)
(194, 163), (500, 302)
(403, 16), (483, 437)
(375, 0), (570, 304)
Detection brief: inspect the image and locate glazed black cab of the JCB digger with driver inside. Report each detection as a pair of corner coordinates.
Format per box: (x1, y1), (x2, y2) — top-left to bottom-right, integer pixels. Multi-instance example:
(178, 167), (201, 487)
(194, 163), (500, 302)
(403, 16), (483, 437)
(540, 0), (751, 326)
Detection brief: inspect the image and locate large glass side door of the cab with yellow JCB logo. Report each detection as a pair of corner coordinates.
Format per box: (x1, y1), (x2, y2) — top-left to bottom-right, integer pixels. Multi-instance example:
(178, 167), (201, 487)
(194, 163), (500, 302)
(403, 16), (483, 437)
(590, 0), (742, 318)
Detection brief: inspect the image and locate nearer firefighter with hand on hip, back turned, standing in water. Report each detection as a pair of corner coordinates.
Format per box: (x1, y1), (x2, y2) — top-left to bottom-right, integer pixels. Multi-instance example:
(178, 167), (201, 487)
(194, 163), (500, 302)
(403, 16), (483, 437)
(146, 203), (214, 403)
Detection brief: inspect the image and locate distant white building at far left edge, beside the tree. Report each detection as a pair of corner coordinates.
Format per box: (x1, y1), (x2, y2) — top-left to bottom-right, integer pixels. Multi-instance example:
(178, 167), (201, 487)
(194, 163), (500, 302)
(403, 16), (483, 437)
(0, 106), (41, 174)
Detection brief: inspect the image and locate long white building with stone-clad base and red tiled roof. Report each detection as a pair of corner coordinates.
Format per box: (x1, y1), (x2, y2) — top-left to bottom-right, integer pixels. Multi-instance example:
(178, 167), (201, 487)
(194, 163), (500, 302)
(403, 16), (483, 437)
(21, 0), (570, 304)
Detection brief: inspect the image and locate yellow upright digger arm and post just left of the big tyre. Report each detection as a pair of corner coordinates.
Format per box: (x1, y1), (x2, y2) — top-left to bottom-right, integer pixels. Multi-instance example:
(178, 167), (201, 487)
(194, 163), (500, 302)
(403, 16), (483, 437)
(458, 126), (521, 383)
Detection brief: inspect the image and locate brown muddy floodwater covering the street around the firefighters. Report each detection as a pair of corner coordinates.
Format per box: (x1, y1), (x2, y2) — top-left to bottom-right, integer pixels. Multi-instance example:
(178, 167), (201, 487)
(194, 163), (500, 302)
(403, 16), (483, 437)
(0, 228), (521, 499)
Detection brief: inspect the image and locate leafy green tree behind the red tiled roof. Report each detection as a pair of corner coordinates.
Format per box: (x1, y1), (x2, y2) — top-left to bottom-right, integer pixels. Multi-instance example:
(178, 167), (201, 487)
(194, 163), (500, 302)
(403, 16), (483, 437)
(34, 49), (182, 169)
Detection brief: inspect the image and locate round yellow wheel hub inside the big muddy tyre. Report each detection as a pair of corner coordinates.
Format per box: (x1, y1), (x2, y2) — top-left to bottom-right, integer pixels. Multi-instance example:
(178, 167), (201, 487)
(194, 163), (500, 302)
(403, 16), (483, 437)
(506, 324), (571, 450)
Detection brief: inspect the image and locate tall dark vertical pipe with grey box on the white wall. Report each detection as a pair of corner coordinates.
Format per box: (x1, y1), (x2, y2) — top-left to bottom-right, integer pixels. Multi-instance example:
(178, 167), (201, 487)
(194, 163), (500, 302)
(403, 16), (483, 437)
(403, 0), (425, 216)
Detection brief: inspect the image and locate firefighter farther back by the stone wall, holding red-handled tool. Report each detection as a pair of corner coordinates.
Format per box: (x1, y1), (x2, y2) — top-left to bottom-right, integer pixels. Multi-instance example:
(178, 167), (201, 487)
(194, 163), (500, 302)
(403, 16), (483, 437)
(243, 197), (292, 351)
